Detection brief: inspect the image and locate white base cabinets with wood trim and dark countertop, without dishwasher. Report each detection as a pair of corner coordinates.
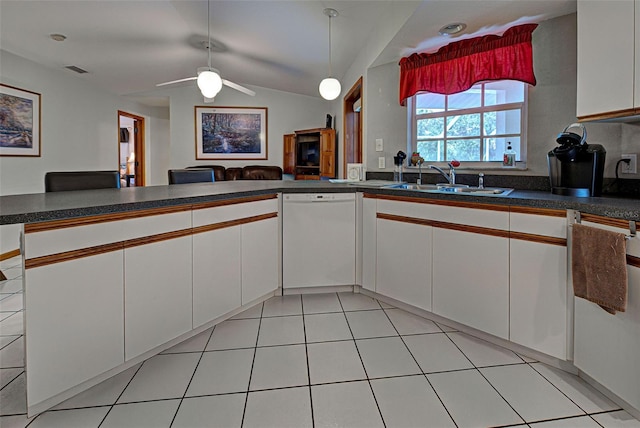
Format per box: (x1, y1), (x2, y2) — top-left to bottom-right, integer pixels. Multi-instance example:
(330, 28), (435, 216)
(0, 181), (640, 417)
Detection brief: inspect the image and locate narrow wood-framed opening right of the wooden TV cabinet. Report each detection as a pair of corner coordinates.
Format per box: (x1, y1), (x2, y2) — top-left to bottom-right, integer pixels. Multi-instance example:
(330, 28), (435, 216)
(342, 76), (364, 174)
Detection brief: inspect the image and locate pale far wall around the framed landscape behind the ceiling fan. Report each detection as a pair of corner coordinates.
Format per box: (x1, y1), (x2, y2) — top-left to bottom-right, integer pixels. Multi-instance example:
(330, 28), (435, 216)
(163, 82), (331, 178)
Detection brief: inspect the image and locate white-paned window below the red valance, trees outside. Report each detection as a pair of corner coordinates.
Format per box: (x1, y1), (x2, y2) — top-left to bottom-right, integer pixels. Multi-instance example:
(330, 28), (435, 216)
(408, 80), (527, 166)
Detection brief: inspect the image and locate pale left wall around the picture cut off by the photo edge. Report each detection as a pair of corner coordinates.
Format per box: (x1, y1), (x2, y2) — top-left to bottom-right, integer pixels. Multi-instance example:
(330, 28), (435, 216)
(0, 51), (165, 195)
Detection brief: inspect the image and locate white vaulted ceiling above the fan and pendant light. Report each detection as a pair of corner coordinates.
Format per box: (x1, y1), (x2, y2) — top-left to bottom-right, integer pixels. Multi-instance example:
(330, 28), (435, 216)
(0, 0), (576, 103)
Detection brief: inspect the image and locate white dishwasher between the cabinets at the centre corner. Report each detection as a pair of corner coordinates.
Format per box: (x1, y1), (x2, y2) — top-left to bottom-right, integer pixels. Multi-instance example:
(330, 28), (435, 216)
(282, 193), (356, 288)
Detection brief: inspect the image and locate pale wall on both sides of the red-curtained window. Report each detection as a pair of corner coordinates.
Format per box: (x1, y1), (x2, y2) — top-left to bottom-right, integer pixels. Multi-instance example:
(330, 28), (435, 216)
(351, 14), (628, 178)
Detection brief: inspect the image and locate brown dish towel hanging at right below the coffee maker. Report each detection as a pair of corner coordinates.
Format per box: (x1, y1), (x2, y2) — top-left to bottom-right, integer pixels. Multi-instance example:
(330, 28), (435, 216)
(571, 224), (627, 314)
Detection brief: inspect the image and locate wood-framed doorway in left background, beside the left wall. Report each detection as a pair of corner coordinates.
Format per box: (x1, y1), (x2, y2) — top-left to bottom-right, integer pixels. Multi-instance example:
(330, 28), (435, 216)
(118, 110), (145, 187)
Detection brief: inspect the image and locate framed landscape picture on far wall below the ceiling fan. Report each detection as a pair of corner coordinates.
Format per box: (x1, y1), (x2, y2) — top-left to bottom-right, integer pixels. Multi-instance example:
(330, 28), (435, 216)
(195, 106), (267, 160)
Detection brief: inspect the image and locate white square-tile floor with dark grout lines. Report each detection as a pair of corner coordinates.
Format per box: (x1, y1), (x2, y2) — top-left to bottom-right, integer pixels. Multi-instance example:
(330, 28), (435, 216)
(0, 258), (640, 428)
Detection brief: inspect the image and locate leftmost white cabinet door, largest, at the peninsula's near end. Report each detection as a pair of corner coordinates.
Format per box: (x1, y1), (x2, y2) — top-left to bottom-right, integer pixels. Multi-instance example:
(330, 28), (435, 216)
(24, 250), (124, 407)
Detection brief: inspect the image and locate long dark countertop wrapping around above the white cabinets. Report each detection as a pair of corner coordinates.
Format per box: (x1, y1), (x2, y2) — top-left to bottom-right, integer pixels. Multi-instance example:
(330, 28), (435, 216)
(0, 180), (640, 224)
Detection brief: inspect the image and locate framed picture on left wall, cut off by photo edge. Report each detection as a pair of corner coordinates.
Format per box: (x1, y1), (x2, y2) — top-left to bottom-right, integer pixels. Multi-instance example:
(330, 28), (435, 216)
(0, 83), (40, 156)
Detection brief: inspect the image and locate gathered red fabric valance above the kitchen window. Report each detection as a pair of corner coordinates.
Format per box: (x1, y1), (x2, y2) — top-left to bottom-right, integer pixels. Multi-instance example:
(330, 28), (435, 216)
(400, 24), (538, 105)
